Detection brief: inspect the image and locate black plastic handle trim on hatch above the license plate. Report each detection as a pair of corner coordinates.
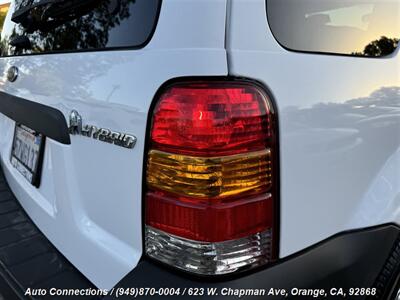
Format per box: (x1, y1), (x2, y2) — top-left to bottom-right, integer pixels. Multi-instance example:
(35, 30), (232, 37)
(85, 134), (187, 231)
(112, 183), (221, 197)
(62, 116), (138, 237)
(0, 92), (71, 145)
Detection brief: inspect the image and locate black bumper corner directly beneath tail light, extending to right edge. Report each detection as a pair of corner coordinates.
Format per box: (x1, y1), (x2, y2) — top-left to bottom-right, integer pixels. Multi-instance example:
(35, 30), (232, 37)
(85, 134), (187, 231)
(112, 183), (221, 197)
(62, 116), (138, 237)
(111, 224), (400, 300)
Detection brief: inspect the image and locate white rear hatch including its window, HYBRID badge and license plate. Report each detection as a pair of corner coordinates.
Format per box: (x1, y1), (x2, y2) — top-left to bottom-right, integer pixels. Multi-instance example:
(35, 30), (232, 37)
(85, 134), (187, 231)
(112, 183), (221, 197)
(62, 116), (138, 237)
(0, 0), (227, 289)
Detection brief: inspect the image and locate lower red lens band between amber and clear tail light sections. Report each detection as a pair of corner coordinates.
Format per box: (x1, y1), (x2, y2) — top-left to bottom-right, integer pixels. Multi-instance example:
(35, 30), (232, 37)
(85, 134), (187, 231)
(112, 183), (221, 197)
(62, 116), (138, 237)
(147, 192), (272, 242)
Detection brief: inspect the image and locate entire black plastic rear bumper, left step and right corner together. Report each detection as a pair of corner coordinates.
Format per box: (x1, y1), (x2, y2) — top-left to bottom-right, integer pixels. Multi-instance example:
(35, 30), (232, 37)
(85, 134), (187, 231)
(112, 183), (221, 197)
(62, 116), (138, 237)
(0, 163), (400, 299)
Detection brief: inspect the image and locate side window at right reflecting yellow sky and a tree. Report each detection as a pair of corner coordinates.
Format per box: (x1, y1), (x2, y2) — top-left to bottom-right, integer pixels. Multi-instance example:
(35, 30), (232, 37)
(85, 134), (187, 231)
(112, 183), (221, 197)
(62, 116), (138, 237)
(267, 0), (400, 57)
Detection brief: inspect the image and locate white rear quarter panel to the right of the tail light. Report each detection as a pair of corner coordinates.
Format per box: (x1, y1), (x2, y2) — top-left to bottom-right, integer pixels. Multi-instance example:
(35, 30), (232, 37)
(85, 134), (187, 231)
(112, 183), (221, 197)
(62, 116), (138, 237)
(227, 0), (400, 257)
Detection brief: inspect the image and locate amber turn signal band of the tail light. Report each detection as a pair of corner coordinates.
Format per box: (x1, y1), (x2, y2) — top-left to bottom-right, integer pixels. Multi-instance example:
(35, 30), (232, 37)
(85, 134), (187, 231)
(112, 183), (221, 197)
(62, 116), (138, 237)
(147, 149), (271, 198)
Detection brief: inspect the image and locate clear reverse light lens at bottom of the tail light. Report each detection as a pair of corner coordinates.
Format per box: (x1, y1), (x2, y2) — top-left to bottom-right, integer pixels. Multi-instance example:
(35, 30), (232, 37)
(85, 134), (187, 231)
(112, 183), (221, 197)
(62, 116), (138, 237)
(146, 226), (272, 275)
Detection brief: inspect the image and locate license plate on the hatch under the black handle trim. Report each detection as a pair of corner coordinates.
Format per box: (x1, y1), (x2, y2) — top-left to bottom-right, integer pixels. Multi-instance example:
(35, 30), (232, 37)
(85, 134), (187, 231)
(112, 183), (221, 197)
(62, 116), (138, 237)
(11, 124), (44, 187)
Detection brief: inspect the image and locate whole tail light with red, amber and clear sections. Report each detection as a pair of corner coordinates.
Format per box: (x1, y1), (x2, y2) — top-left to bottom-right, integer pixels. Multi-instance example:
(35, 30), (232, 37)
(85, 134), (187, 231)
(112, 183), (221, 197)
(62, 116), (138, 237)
(145, 81), (278, 275)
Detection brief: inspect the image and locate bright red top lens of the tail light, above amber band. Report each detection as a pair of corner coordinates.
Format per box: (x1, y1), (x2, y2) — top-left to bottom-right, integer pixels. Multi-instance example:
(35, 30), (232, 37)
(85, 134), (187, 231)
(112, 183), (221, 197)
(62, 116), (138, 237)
(151, 83), (271, 156)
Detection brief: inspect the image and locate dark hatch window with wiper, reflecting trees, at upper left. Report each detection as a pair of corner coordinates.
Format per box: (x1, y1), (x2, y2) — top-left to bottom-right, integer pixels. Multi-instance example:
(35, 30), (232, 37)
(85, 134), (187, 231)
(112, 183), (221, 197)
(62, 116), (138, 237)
(1, 0), (161, 56)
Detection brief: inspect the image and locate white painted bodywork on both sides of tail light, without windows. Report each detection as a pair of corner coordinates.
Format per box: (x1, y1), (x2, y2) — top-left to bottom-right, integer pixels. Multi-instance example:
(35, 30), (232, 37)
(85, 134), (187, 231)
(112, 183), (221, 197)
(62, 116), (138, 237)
(0, 0), (400, 289)
